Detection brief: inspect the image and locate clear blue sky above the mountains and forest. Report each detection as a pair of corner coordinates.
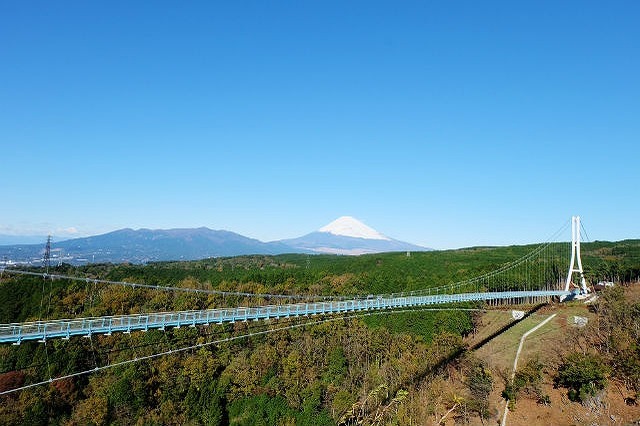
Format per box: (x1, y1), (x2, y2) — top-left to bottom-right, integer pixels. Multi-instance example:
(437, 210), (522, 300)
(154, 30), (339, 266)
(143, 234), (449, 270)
(0, 0), (640, 248)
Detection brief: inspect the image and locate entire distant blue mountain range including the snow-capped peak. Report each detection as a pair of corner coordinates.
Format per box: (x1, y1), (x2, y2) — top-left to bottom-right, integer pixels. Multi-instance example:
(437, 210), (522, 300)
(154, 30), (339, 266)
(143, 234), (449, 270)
(0, 216), (429, 265)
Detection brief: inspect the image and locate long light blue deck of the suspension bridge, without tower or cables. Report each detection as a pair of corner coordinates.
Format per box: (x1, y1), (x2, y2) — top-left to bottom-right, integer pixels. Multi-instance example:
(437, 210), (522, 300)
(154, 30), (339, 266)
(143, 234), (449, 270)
(0, 290), (571, 344)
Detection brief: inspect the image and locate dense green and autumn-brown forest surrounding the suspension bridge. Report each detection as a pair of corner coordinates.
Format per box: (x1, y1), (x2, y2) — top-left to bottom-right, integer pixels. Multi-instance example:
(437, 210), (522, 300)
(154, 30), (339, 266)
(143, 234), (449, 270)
(0, 240), (640, 425)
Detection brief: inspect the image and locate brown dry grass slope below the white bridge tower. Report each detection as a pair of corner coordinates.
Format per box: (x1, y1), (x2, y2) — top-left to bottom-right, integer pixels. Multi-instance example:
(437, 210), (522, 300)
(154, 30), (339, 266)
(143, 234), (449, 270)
(468, 292), (640, 426)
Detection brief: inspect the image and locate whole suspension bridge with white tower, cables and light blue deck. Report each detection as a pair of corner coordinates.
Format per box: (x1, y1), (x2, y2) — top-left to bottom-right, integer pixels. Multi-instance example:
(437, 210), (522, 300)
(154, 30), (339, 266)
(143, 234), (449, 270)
(0, 216), (589, 345)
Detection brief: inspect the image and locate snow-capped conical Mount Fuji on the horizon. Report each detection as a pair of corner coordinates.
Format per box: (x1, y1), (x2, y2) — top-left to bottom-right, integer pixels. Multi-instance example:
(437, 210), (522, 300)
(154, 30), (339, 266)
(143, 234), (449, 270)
(279, 216), (430, 255)
